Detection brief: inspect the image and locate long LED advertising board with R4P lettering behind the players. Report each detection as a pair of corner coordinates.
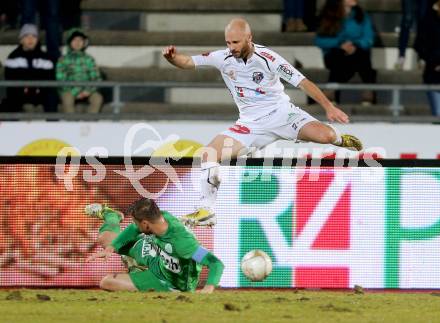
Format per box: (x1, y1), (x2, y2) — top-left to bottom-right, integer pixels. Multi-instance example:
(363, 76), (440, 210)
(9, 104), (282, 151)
(0, 156), (440, 289)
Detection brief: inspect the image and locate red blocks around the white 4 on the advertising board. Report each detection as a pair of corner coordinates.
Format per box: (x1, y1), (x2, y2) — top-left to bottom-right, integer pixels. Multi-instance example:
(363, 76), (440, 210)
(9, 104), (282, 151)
(293, 168), (351, 288)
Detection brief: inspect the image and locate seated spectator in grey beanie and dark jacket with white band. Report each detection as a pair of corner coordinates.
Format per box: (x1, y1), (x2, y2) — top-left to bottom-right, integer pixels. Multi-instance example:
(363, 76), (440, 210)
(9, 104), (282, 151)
(3, 24), (56, 112)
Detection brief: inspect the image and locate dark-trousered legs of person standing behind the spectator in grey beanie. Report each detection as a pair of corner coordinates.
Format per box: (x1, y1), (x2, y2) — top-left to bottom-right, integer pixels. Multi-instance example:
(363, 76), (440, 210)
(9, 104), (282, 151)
(21, 0), (61, 63)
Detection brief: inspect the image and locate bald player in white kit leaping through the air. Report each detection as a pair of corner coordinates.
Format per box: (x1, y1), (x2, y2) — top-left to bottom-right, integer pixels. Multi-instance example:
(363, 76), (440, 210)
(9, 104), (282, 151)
(162, 18), (362, 226)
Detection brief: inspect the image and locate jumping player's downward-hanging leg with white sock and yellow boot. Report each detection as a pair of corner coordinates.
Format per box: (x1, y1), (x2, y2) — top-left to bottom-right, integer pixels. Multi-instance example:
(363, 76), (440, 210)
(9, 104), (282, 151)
(181, 133), (248, 226)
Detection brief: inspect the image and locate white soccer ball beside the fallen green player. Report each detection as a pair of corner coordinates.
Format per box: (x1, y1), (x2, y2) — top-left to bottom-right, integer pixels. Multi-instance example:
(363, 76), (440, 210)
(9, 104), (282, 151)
(241, 250), (272, 282)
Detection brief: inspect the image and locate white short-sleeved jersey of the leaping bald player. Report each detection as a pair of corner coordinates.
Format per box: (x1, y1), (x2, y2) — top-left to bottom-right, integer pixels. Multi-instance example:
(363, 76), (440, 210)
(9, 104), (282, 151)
(192, 44), (305, 122)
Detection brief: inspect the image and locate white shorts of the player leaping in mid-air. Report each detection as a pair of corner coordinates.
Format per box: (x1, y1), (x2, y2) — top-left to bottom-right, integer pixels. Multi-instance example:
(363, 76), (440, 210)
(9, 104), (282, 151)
(222, 104), (318, 153)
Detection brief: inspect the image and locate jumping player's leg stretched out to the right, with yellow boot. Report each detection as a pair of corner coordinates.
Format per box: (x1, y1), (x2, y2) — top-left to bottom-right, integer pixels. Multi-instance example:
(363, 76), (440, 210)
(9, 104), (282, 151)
(297, 120), (362, 151)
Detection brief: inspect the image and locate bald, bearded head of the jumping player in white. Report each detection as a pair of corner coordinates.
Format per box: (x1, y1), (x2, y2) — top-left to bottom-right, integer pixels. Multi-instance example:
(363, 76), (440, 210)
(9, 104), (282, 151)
(225, 18), (253, 58)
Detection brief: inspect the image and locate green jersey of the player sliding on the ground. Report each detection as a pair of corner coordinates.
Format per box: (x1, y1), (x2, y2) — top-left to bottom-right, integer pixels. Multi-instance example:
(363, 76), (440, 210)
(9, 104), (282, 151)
(112, 211), (202, 291)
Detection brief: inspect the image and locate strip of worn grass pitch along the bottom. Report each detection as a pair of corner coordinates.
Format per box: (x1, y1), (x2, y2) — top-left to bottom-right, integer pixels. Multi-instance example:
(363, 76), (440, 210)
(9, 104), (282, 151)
(0, 289), (440, 323)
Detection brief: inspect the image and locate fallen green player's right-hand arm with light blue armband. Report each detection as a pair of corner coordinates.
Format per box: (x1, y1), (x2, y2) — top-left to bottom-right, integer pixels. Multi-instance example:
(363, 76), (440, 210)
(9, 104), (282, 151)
(192, 246), (225, 293)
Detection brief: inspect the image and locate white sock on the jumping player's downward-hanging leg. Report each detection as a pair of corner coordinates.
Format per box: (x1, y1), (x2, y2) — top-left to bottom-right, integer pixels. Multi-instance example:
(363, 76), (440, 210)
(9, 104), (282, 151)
(199, 162), (221, 211)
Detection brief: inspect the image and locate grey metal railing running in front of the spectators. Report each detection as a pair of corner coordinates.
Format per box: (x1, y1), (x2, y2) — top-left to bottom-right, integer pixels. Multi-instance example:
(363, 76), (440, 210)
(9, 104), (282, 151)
(0, 81), (440, 122)
